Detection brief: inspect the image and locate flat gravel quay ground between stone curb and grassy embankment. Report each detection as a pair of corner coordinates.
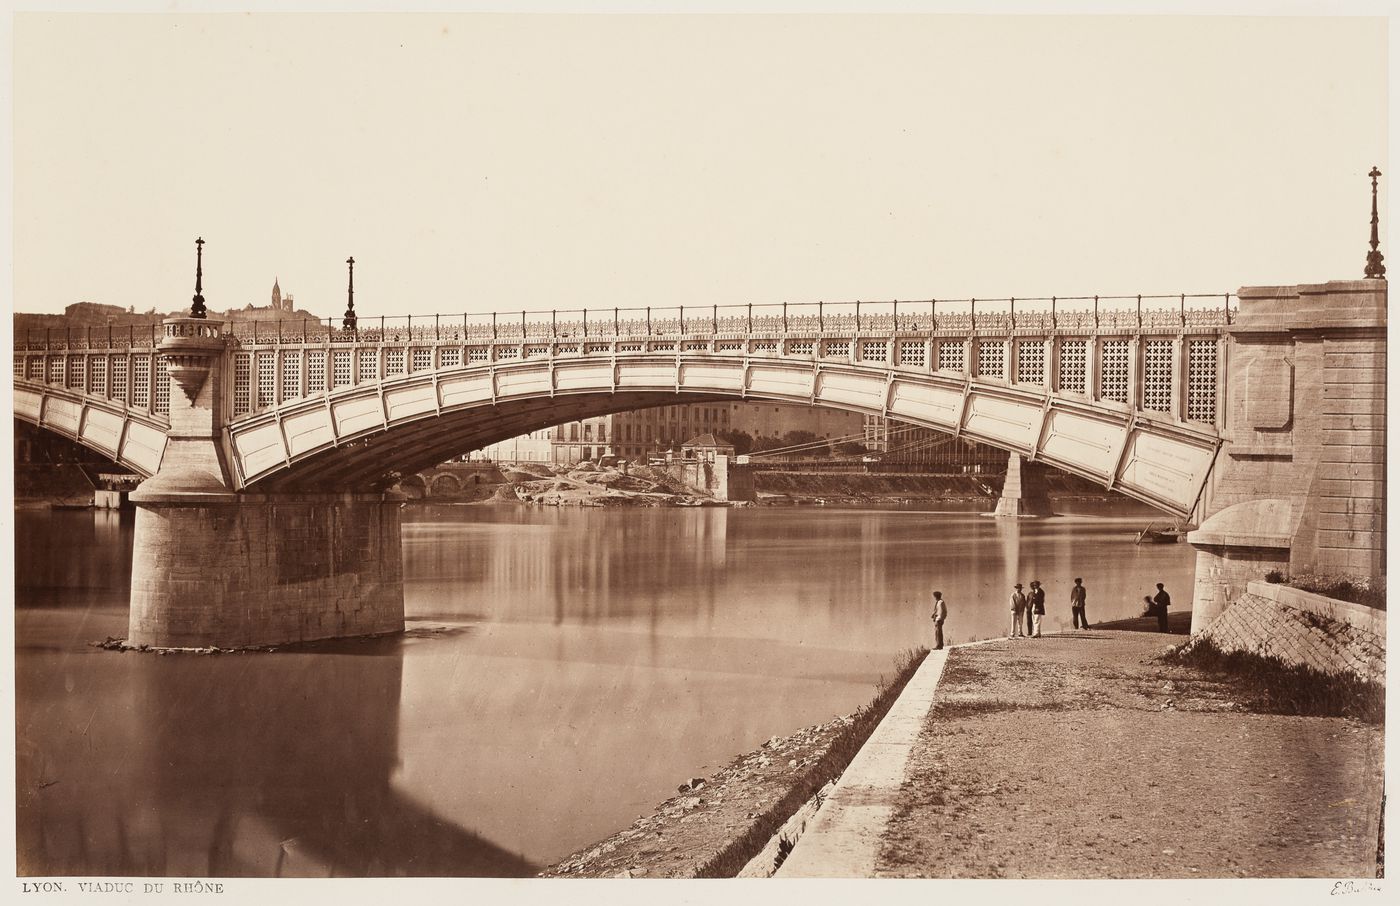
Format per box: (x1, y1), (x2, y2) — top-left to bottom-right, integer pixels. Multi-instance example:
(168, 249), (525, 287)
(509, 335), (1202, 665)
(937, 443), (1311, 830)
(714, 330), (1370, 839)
(876, 627), (1383, 878)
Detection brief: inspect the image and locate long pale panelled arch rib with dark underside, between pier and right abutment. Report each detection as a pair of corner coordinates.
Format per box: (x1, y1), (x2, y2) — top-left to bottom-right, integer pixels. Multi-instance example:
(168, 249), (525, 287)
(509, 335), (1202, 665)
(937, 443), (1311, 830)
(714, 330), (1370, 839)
(225, 354), (1218, 517)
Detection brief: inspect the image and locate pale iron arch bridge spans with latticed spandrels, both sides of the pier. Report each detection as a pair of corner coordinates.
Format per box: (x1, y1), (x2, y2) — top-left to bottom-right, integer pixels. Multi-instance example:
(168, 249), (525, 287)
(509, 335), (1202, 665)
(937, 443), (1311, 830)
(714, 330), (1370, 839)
(14, 294), (1233, 517)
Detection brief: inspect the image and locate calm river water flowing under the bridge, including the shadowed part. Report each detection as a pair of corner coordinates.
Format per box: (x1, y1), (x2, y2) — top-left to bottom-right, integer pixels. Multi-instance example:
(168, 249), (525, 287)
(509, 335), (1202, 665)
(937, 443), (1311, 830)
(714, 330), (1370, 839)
(15, 501), (1194, 877)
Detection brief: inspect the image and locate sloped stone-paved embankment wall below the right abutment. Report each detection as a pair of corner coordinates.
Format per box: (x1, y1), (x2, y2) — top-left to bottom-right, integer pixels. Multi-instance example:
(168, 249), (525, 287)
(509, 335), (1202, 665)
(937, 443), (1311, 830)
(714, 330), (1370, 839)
(1191, 581), (1386, 683)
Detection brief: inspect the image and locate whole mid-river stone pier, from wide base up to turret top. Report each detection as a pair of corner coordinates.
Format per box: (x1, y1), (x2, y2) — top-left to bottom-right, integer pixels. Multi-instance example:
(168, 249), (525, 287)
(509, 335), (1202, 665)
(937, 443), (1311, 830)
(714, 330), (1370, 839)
(127, 318), (403, 648)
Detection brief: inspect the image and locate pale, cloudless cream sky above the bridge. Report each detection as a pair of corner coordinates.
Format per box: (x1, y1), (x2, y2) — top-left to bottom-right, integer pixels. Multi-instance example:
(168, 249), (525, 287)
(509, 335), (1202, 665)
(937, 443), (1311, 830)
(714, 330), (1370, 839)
(13, 11), (1400, 316)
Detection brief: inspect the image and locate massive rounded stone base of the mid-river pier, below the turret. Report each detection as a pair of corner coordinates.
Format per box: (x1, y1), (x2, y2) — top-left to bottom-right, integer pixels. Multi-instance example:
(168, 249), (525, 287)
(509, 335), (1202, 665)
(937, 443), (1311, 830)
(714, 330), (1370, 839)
(127, 489), (403, 648)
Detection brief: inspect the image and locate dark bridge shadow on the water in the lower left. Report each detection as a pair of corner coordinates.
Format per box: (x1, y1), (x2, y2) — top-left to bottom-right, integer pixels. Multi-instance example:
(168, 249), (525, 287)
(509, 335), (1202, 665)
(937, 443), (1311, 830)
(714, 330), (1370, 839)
(17, 637), (539, 878)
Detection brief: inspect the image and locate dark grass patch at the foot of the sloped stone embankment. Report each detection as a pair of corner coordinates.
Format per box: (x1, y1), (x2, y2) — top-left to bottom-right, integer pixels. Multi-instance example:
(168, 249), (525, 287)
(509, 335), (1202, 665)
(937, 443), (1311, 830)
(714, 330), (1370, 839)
(1158, 639), (1386, 725)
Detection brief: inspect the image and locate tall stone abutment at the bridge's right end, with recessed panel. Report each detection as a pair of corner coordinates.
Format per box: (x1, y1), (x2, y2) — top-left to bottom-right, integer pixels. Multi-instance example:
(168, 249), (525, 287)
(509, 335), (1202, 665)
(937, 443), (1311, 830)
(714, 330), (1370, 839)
(1187, 279), (1387, 633)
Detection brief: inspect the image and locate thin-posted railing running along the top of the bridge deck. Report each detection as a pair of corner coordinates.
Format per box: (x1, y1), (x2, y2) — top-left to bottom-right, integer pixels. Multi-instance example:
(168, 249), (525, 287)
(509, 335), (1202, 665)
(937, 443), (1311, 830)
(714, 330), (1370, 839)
(15, 293), (1236, 350)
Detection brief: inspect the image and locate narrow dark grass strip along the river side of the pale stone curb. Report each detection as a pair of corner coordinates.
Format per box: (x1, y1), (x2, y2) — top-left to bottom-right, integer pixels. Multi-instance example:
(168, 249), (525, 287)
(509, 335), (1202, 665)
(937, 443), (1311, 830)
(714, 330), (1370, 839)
(696, 647), (928, 878)
